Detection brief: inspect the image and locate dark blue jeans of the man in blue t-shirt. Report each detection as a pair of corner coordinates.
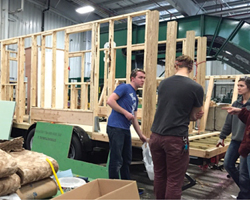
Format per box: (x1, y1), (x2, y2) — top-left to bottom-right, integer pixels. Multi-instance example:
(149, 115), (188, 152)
(107, 126), (132, 180)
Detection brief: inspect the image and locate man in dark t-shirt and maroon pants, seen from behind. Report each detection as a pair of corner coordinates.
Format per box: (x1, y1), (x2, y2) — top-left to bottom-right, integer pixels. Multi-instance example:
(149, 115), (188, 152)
(149, 55), (204, 199)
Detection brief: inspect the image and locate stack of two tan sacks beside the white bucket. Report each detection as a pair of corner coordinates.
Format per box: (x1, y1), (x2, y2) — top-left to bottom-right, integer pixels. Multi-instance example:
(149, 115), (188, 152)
(10, 150), (59, 199)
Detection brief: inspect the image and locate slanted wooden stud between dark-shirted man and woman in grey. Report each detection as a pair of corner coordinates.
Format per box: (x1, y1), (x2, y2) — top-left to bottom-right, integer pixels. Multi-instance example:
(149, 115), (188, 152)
(200, 76), (214, 133)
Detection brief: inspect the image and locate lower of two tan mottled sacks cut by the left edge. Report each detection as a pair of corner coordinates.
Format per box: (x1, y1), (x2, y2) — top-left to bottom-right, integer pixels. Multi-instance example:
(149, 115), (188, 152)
(0, 174), (20, 196)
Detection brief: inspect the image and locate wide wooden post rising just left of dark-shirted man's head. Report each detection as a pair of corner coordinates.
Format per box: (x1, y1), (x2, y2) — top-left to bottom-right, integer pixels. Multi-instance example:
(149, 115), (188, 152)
(165, 21), (177, 77)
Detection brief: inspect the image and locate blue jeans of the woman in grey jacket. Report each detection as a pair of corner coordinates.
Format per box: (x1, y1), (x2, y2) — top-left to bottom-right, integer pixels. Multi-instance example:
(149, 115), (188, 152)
(224, 140), (241, 187)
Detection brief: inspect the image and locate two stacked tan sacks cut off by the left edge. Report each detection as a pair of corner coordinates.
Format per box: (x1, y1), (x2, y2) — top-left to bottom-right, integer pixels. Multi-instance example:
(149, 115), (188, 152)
(0, 149), (21, 196)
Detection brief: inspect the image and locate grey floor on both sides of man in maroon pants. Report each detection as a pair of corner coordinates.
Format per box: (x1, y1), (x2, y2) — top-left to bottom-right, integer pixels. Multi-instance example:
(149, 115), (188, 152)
(130, 164), (239, 199)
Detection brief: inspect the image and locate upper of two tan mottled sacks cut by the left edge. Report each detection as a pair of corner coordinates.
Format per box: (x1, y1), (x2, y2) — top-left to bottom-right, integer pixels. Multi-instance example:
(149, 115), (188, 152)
(0, 149), (18, 178)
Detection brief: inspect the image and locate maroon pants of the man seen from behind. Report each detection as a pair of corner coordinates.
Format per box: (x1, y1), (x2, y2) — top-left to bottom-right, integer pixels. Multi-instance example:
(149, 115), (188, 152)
(149, 133), (189, 199)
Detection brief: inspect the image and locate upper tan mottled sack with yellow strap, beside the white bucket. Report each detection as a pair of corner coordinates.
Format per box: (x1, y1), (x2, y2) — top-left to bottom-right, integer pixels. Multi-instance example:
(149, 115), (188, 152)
(10, 150), (59, 185)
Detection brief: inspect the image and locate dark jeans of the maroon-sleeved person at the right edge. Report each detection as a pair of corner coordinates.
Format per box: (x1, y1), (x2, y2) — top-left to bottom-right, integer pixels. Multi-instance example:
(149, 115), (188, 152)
(237, 156), (250, 199)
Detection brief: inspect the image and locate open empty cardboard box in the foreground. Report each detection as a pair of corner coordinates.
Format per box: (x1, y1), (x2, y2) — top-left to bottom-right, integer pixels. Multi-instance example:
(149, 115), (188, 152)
(53, 179), (140, 199)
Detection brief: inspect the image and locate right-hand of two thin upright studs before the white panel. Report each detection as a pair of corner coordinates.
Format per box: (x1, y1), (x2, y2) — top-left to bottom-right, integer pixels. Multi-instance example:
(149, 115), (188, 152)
(51, 32), (57, 108)
